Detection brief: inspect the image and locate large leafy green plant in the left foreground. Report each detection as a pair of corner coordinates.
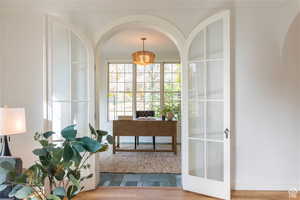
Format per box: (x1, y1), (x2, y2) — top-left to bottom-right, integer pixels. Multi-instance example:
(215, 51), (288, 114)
(0, 125), (112, 200)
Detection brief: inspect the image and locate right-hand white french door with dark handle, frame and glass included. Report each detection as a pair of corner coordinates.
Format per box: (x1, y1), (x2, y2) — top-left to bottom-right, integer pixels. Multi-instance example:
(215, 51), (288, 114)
(182, 11), (230, 199)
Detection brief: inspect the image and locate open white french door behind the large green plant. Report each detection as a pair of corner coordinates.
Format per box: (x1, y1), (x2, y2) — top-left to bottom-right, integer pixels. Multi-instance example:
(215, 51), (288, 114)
(45, 16), (97, 190)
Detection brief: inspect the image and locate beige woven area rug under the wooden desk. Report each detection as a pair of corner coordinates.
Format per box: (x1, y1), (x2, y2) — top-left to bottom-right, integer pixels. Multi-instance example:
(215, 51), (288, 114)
(98, 144), (181, 174)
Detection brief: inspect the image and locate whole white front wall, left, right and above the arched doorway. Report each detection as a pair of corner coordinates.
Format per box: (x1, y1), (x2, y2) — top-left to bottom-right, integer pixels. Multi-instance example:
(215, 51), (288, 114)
(0, 1), (300, 190)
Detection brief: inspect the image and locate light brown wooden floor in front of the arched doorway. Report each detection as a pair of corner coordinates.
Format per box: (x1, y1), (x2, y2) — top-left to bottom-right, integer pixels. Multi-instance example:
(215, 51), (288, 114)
(76, 187), (292, 200)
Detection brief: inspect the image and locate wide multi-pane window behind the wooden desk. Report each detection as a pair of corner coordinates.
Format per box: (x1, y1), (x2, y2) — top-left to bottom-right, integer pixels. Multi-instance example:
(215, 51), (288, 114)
(108, 63), (181, 120)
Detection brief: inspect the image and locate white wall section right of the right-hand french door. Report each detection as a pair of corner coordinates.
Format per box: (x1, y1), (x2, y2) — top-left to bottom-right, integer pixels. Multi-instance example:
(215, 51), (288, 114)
(234, 6), (299, 189)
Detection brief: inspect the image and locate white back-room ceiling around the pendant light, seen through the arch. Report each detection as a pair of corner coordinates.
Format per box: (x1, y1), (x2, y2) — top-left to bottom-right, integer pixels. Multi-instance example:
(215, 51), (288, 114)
(102, 25), (179, 60)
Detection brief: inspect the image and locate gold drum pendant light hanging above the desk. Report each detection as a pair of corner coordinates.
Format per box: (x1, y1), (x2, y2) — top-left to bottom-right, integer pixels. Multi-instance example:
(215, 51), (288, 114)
(132, 38), (155, 66)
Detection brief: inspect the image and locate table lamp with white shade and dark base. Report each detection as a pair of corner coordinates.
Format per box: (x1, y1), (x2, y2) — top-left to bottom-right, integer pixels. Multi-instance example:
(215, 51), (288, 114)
(0, 107), (26, 156)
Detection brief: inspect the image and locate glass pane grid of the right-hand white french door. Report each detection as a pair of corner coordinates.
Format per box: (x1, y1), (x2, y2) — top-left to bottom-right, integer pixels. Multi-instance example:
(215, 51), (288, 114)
(189, 20), (224, 181)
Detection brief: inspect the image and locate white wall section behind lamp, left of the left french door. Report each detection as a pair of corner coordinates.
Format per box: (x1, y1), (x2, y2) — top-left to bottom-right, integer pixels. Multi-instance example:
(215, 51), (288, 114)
(0, 11), (43, 167)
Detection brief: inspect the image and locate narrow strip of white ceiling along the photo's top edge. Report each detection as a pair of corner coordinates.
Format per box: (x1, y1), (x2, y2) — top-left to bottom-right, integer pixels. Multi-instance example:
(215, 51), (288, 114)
(0, 0), (290, 10)
